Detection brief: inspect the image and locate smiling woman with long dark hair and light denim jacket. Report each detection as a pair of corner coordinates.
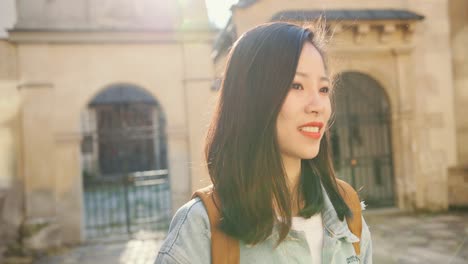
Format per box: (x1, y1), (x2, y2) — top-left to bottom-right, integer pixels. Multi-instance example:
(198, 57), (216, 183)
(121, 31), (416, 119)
(156, 23), (371, 264)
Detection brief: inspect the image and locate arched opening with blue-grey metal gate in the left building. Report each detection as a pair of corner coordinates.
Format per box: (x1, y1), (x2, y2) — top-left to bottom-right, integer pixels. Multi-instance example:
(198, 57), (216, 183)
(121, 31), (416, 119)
(81, 84), (171, 239)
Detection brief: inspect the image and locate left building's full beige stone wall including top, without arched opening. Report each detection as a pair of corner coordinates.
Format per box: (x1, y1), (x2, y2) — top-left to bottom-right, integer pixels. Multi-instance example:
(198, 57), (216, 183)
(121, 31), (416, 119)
(0, 0), (216, 245)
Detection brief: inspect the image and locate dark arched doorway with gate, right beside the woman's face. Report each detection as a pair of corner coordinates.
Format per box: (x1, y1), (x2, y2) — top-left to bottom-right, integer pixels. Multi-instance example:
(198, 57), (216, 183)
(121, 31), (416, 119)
(331, 72), (395, 207)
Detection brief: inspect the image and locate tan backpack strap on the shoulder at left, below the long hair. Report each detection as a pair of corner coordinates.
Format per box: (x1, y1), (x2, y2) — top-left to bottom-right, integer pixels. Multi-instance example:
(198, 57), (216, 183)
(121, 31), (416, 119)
(192, 185), (240, 264)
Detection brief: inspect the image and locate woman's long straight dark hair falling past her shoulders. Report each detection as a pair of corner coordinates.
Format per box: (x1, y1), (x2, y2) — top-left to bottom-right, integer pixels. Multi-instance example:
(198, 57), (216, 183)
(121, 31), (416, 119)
(205, 22), (350, 244)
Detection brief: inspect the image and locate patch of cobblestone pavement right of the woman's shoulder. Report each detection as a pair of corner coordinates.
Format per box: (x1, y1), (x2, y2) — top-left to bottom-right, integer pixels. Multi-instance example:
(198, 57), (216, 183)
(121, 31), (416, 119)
(365, 211), (468, 264)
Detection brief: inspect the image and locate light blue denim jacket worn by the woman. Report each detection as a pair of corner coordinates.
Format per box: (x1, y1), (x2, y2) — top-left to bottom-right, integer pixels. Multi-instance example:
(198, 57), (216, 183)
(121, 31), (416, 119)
(155, 189), (372, 264)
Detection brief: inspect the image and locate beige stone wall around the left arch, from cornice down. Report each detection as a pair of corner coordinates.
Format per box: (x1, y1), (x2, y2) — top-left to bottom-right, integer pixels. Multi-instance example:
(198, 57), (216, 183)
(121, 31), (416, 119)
(11, 23), (214, 243)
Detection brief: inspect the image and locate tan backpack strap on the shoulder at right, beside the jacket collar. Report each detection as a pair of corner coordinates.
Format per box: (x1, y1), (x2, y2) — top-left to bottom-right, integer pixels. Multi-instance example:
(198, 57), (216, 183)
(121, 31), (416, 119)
(336, 179), (362, 255)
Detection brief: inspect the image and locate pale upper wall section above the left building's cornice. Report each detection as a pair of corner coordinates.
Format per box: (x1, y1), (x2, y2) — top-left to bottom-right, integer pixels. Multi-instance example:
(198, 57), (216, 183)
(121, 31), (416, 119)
(15, 0), (209, 31)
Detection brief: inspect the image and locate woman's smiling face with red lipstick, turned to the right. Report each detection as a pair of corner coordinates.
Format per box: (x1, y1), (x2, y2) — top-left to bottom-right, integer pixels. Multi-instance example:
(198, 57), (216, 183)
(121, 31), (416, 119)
(276, 42), (331, 160)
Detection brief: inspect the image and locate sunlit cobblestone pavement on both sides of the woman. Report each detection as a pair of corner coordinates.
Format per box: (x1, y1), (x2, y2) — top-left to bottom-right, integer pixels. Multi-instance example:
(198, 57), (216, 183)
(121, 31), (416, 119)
(34, 209), (468, 264)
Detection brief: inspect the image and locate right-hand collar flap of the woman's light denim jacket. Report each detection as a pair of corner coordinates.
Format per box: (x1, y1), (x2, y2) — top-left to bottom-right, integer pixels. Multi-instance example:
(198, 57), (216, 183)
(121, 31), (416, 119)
(322, 185), (359, 243)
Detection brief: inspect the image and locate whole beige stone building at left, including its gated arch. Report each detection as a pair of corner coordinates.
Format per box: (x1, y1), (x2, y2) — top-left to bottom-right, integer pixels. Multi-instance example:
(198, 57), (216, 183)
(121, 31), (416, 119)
(0, 0), (217, 255)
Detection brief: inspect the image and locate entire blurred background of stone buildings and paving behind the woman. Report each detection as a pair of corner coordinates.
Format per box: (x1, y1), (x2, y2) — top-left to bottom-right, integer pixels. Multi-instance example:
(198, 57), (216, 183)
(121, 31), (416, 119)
(0, 0), (468, 263)
